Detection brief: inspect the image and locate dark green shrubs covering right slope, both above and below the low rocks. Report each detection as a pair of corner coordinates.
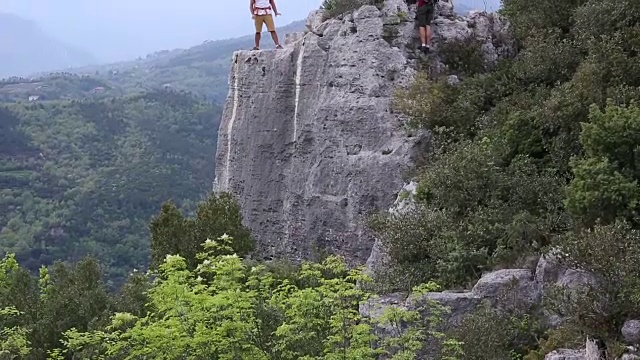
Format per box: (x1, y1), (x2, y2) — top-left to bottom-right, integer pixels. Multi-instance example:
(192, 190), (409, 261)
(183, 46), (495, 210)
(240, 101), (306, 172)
(371, 0), (640, 359)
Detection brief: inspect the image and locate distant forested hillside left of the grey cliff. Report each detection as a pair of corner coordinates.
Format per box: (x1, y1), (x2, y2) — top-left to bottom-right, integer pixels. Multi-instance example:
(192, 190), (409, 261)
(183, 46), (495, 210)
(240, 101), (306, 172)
(0, 91), (220, 283)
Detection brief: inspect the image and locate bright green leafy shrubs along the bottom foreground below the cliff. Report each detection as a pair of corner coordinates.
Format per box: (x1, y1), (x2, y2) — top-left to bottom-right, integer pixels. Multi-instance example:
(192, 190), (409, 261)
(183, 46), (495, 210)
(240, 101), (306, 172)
(0, 233), (460, 360)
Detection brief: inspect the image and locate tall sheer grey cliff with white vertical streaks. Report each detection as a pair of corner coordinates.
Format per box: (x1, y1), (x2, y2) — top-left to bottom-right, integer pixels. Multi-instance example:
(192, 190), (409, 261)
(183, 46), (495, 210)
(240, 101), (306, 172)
(214, 0), (510, 264)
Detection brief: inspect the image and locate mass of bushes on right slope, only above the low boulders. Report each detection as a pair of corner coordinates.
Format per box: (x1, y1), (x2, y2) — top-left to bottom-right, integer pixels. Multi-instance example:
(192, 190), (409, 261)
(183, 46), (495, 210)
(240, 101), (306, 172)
(372, 0), (640, 298)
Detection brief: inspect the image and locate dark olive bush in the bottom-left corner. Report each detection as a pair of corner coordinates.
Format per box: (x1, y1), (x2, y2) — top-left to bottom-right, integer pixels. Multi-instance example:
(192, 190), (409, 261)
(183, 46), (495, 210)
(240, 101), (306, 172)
(0, 254), (113, 359)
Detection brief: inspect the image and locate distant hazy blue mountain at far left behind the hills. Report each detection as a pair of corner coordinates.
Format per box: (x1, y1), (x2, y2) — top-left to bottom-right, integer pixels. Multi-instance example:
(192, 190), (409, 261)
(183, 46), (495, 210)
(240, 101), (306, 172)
(0, 13), (97, 77)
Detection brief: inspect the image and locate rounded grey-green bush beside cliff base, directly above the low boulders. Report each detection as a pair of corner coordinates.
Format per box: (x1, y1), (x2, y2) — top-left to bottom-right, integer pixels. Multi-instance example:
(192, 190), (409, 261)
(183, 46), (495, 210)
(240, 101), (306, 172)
(371, 139), (568, 286)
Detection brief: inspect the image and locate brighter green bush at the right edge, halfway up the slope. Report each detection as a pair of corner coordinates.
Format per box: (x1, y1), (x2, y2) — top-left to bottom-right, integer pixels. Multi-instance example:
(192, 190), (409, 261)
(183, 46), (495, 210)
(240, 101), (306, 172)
(566, 101), (640, 225)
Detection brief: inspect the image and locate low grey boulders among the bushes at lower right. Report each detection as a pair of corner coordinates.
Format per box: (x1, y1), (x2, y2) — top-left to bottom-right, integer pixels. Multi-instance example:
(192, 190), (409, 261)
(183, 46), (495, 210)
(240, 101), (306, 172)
(360, 255), (604, 360)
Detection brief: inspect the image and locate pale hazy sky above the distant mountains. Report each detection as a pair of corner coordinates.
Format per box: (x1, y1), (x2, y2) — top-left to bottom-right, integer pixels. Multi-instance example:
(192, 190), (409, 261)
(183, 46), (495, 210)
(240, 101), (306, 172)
(0, 0), (322, 61)
